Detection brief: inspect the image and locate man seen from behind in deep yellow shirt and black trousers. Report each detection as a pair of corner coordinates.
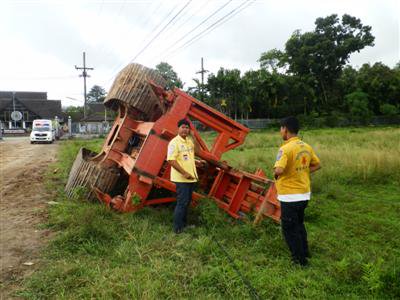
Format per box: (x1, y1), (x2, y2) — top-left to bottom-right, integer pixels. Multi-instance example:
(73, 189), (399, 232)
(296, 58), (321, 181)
(274, 117), (321, 266)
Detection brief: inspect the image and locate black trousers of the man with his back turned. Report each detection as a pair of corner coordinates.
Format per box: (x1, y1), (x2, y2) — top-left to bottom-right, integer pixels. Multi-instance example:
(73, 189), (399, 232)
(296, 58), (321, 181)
(281, 201), (309, 264)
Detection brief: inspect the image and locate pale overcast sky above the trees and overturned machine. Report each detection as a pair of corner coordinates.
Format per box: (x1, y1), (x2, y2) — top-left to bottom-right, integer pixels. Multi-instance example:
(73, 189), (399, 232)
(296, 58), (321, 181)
(0, 0), (400, 106)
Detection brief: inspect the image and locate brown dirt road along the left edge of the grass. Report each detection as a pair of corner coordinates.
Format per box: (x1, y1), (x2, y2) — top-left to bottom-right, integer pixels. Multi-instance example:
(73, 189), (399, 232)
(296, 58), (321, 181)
(0, 137), (58, 299)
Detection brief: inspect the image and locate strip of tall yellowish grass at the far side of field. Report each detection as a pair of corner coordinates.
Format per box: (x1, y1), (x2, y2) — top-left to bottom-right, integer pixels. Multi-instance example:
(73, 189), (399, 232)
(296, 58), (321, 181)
(223, 128), (400, 189)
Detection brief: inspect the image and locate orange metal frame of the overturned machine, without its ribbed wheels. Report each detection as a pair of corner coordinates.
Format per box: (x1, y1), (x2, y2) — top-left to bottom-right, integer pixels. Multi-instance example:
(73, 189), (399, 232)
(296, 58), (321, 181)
(94, 82), (280, 222)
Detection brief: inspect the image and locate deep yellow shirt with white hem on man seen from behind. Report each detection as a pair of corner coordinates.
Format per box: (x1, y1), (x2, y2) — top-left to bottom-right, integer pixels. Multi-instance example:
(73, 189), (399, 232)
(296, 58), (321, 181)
(274, 137), (320, 202)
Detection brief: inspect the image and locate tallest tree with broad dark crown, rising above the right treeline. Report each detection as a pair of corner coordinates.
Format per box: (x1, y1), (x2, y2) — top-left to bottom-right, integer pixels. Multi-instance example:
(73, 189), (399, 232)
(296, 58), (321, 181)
(281, 14), (375, 106)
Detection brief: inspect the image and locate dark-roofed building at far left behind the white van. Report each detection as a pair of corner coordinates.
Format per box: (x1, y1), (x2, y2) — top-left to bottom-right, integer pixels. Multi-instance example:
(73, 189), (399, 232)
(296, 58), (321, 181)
(0, 91), (62, 129)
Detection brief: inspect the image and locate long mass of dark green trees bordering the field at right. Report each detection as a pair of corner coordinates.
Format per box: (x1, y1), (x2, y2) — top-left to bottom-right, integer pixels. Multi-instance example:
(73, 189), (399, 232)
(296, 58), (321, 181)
(198, 14), (400, 123)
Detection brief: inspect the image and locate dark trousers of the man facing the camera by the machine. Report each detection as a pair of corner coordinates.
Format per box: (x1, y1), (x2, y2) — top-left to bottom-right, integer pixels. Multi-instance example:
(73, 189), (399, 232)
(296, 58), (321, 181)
(174, 182), (195, 232)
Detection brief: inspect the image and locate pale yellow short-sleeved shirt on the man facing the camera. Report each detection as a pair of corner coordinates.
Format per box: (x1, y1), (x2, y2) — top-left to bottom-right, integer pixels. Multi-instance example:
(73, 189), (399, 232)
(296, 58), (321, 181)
(167, 135), (198, 182)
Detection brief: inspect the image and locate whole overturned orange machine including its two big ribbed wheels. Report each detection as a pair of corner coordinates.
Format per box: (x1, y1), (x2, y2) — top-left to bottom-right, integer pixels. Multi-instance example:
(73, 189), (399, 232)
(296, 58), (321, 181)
(65, 64), (280, 222)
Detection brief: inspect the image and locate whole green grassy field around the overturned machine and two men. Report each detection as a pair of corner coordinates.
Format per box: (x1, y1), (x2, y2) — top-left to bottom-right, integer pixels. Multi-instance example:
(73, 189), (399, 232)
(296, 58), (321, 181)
(18, 128), (400, 299)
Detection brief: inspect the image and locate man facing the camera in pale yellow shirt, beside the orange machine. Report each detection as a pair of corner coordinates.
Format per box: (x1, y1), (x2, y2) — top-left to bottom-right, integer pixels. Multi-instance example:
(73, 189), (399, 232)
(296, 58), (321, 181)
(167, 119), (202, 233)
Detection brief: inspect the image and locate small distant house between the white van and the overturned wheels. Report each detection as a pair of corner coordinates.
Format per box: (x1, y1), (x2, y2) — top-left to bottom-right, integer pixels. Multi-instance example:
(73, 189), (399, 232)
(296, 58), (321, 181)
(80, 102), (115, 133)
